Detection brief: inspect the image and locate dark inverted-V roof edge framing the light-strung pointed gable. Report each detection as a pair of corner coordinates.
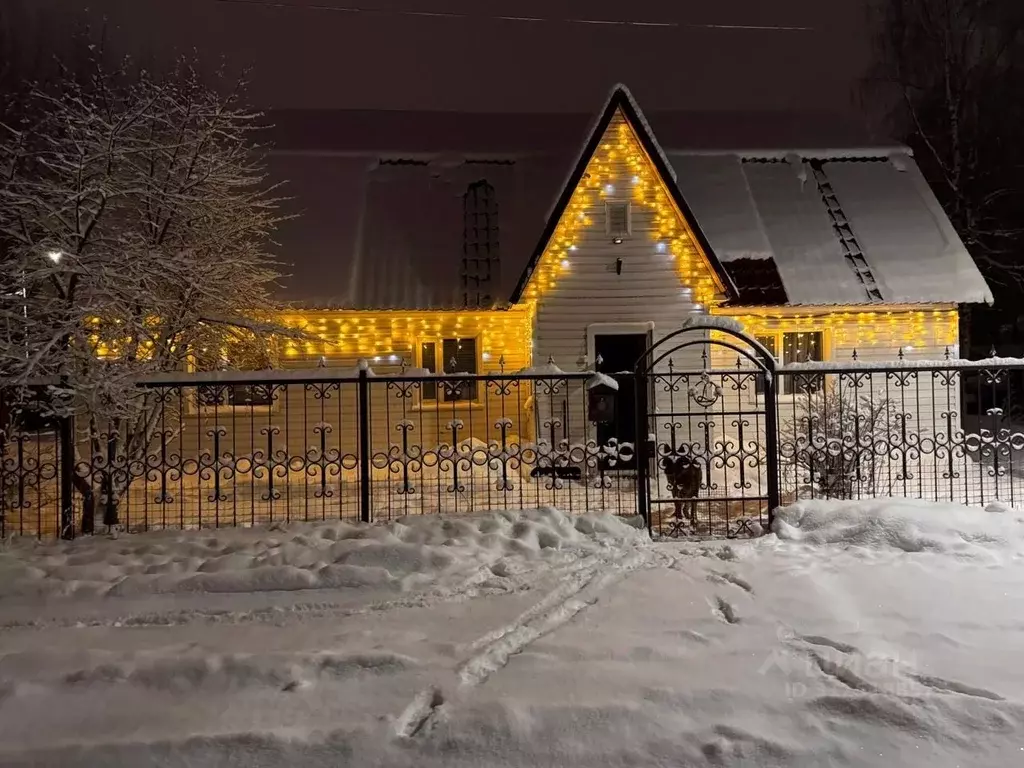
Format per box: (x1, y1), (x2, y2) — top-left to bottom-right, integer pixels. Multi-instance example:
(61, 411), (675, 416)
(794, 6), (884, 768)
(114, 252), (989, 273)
(512, 85), (738, 304)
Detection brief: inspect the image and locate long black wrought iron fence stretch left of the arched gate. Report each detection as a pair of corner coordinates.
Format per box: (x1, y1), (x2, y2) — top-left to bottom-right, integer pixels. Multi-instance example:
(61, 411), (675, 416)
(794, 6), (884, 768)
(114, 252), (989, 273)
(0, 369), (636, 537)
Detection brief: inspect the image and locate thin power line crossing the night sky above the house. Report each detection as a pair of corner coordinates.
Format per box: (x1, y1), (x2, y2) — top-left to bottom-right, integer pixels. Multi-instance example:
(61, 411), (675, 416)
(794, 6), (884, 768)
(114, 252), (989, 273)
(217, 0), (814, 32)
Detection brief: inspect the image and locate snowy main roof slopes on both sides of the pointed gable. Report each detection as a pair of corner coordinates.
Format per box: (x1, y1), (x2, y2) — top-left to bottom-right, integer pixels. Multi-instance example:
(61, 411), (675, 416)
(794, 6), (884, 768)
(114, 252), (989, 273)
(269, 91), (990, 309)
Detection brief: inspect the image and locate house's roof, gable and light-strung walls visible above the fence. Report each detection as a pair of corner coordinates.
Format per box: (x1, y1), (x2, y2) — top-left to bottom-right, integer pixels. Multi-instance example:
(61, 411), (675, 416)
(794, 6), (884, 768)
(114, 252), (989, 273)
(251, 87), (991, 450)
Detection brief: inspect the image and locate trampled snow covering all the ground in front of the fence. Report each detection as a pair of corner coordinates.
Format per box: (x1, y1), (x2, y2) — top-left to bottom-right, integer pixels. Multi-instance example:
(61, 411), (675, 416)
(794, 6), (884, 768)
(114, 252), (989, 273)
(0, 500), (1024, 768)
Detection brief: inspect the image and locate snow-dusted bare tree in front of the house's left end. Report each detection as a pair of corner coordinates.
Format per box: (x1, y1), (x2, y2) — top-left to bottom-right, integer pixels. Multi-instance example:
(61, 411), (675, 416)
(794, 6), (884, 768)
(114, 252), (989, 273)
(0, 55), (278, 529)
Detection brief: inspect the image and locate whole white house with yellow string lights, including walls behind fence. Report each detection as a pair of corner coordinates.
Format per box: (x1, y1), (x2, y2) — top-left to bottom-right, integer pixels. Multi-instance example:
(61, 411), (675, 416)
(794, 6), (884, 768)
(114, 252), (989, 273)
(4, 87), (991, 532)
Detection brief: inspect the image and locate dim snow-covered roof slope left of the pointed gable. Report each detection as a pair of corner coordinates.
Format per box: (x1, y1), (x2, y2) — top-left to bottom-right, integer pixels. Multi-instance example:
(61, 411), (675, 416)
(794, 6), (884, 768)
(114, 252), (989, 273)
(270, 152), (565, 309)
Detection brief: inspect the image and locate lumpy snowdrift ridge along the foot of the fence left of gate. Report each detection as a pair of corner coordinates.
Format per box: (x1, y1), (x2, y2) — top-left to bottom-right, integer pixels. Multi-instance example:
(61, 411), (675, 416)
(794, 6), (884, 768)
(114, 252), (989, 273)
(0, 508), (645, 598)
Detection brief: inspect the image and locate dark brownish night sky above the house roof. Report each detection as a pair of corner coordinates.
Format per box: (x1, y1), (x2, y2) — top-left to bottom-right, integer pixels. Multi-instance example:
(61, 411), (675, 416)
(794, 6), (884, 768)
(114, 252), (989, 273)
(22, 0), (869, 112)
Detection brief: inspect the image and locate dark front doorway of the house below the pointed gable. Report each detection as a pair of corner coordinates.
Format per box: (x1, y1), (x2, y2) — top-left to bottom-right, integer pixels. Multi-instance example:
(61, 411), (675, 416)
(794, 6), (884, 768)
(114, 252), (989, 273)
(594, 333), (649, 471)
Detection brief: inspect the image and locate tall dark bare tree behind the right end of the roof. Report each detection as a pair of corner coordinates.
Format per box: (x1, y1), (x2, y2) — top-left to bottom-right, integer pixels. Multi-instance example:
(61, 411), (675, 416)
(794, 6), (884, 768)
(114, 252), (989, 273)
(865, 0), (1024, 288)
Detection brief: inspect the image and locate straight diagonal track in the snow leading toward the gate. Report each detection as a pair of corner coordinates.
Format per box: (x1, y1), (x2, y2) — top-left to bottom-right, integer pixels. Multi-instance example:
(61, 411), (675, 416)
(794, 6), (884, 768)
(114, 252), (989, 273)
(457, 552), (651, 686)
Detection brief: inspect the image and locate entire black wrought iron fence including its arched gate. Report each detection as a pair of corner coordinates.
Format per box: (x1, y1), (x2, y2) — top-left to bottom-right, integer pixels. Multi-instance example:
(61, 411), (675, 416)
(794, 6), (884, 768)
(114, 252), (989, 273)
(0, 350), (1024, 537)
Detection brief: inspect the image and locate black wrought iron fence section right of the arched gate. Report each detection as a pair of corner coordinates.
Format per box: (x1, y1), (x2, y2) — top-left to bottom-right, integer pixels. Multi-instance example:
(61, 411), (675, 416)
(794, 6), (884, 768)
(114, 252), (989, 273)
(777, 359), (1024, 506)
